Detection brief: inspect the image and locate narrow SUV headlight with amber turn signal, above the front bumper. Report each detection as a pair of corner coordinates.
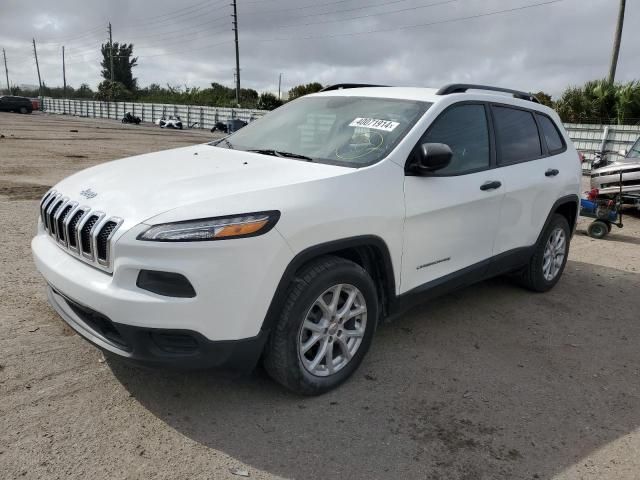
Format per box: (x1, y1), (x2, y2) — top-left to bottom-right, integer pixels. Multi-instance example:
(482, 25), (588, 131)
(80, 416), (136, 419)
(138, 210), (280, 242)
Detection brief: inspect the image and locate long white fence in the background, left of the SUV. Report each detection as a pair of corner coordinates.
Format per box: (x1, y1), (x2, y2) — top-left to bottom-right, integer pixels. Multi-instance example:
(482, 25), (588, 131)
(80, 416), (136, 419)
(40, 97), (266, 129)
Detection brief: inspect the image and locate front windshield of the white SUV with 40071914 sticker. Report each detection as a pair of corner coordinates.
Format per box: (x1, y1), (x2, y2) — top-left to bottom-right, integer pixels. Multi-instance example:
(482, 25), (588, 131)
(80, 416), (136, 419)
(210, 96), (431, 167)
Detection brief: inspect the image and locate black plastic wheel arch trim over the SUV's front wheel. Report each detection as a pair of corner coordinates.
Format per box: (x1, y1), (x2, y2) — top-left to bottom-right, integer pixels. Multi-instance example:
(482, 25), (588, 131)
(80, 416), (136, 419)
(261, 235), (396, 331)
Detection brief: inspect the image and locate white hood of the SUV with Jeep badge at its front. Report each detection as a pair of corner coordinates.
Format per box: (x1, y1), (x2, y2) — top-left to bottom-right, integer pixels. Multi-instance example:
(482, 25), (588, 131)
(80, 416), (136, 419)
(53, 144), (353, 227)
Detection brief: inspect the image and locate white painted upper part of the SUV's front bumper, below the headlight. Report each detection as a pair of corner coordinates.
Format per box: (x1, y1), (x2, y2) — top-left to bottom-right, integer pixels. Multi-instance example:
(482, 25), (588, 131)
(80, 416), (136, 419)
(31, 223), (291, 342)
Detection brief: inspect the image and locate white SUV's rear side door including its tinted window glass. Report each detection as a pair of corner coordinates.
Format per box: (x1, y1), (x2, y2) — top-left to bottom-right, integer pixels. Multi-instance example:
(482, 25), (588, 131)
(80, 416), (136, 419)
(491, 104), (568, 255)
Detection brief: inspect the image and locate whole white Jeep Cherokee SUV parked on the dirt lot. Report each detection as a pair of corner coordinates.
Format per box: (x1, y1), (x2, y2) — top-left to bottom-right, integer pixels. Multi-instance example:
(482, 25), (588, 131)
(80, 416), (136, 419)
(32, 84), (581, 394)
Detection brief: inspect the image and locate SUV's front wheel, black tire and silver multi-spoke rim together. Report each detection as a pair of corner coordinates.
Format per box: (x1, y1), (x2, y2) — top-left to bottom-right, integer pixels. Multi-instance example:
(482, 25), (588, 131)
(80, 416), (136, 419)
(264, 256), (378, 395)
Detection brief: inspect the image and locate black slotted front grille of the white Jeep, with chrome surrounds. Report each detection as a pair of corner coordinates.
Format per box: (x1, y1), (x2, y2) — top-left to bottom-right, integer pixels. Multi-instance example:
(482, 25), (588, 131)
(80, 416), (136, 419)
(40, 190), (122, 270)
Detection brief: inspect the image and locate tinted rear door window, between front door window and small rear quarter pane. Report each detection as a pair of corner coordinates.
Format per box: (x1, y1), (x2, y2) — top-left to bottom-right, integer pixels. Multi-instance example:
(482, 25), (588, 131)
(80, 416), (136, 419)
(492, 105), (542, 165)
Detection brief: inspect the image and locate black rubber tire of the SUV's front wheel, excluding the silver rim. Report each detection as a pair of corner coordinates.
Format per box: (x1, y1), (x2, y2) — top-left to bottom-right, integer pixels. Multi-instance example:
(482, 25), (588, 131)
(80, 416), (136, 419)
(264, 256), (379, 395)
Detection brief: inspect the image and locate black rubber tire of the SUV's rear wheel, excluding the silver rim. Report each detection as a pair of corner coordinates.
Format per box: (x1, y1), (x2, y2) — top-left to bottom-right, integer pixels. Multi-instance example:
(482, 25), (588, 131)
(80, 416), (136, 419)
(519, 213), (571, 292)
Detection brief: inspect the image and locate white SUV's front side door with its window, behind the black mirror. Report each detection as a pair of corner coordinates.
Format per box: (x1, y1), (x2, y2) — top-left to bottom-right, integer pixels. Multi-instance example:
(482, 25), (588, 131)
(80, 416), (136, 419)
(400, 102), (505, 293)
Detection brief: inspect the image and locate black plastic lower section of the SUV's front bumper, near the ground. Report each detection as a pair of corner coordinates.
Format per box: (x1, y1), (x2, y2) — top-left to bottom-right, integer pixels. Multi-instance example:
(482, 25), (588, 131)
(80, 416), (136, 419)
(47, 286), (267, 373)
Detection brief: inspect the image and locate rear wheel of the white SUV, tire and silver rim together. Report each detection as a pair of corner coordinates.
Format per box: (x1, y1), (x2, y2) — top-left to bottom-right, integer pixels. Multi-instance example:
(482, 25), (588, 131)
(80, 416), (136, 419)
(521, 213), (570, 292)
